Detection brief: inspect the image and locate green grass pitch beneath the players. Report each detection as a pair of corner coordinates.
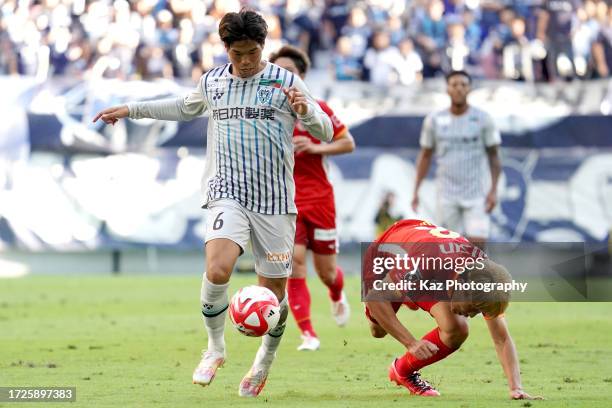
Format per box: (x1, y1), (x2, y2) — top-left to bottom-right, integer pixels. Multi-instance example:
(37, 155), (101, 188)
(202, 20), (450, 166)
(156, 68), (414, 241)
(0, 275), (612, 408)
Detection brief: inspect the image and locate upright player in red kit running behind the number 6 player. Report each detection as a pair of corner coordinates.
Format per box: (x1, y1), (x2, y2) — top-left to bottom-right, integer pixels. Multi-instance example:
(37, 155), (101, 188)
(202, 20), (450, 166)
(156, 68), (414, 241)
(270, 46), (355, 350)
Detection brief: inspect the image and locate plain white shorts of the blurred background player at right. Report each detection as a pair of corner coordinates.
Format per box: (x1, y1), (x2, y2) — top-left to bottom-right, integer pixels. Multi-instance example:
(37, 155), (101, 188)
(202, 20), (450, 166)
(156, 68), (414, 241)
(437, 197), (491, 239)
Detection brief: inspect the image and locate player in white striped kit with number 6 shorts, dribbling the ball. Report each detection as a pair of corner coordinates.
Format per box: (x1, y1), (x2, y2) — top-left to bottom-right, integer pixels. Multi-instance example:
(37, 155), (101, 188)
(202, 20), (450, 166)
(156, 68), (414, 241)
(94, 9), (332, 397)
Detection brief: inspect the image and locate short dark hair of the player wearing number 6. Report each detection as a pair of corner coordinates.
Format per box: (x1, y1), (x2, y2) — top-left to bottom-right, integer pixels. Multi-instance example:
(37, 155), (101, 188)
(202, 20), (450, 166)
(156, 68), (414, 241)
(219, 8), (268, 47)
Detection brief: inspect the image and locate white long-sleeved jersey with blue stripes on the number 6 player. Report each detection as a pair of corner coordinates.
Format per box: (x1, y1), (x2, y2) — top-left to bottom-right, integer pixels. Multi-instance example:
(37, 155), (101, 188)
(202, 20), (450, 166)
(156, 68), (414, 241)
(128, 62), (333, 214)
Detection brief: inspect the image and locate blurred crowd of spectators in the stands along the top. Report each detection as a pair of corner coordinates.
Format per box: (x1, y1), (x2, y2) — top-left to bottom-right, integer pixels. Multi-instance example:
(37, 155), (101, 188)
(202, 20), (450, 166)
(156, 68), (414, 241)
(0, 0), (612, 86)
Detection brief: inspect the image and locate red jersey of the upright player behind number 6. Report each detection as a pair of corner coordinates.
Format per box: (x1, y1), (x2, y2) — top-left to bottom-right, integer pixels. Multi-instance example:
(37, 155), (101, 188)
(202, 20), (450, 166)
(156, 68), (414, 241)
(293, 101), (346, 210)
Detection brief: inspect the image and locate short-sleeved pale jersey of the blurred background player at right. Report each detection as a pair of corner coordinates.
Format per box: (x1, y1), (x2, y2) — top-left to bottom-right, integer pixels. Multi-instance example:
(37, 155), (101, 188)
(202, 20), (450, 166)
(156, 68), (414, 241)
(420, 107), (501, 199)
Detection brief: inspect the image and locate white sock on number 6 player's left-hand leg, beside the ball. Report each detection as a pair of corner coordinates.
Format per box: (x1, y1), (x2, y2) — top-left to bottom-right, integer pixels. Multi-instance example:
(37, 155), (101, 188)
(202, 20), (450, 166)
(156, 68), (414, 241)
(200, 274), (230, 354)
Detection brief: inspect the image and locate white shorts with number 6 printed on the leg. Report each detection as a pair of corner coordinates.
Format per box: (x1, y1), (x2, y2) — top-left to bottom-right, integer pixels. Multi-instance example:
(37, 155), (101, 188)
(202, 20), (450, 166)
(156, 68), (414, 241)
(205, 198), (296, 278)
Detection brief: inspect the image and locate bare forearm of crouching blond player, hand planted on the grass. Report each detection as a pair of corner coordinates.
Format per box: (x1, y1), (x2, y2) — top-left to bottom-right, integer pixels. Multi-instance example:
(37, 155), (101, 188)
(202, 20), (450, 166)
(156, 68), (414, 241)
(487, 316), (543, 399)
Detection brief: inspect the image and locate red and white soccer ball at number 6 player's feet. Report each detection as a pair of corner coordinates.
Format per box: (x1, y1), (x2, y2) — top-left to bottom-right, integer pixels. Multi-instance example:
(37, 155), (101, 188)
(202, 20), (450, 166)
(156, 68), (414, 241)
(229, 285), (280, 337)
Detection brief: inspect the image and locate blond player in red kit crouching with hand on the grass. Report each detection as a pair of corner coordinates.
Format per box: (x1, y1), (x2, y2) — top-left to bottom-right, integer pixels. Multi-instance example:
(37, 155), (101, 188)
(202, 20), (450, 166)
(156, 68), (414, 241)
(363, 220), (541, 399)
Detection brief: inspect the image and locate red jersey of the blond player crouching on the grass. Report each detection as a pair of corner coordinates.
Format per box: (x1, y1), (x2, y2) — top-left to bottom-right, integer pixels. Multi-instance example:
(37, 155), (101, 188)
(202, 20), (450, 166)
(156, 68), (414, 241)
(364, 220), (487, 301)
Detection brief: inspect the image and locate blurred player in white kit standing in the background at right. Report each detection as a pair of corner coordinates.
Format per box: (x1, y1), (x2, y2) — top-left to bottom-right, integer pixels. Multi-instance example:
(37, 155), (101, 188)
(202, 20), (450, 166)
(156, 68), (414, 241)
(412, 71), (501, 246)
